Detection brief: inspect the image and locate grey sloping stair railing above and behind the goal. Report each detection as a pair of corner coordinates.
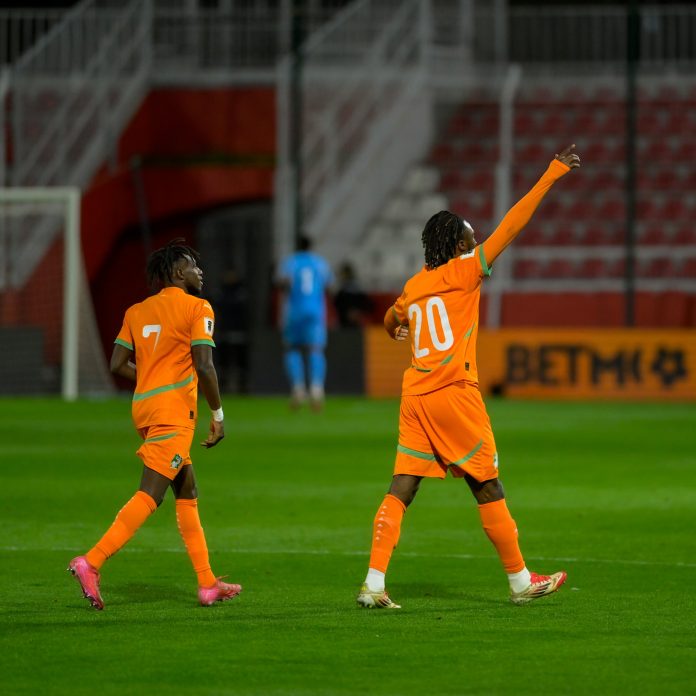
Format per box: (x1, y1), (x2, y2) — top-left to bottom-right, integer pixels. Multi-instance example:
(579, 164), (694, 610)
(5, 0), (152, 286)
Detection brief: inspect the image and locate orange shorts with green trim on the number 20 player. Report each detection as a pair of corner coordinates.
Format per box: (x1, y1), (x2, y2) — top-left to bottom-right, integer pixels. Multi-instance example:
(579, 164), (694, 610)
(394, 382), (498, 481)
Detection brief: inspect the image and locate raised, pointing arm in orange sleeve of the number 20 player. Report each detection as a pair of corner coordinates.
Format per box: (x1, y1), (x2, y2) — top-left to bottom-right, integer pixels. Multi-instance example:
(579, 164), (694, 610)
(483, 145), (580, 266)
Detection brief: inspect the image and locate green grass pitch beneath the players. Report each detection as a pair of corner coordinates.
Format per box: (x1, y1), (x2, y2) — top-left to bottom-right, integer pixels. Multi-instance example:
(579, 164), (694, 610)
(0, 398), (696, 696)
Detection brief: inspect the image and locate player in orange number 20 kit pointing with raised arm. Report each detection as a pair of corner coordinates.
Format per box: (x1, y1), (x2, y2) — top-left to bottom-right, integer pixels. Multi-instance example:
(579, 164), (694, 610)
(357, 145), (580, 609)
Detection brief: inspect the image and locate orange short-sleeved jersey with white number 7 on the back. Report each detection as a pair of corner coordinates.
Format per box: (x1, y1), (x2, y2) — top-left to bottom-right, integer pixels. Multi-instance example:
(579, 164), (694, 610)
(115, 287), (215, 428)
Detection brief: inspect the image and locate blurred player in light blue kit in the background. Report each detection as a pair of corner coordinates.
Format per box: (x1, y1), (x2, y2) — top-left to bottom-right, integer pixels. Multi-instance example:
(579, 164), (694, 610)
(278, 236), (334, 411)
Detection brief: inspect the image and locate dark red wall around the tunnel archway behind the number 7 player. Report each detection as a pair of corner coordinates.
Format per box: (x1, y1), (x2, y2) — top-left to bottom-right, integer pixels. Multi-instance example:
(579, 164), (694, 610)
(82, 88), (275, 353)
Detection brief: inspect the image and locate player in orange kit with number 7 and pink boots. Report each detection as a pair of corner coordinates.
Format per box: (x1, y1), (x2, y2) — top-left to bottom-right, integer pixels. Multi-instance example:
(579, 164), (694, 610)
(68, 239), (242, 609)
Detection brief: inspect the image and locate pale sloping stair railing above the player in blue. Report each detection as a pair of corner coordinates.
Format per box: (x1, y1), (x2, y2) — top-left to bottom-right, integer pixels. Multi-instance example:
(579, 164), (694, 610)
(276, 0), (432, 260)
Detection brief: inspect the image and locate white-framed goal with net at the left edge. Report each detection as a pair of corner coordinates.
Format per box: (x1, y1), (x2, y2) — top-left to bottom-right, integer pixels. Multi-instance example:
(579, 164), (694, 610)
(0, 188), (114, 400)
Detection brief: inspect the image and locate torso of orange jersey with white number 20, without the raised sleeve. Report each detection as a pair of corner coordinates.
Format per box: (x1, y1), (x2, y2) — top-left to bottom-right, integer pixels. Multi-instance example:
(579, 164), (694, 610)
(394, 245), (490, 395)
